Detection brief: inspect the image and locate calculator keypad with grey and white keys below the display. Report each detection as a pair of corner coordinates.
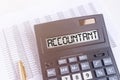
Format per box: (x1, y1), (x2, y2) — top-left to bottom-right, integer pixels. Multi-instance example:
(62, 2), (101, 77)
(47, 55), (118, 80)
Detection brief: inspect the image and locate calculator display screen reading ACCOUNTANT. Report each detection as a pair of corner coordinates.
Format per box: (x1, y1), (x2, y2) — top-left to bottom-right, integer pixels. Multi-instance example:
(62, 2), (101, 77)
(46, 30), (99, 49)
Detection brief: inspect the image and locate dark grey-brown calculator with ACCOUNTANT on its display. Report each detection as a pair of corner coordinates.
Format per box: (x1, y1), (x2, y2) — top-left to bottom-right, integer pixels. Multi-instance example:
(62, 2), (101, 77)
(34, 14), (120, 80)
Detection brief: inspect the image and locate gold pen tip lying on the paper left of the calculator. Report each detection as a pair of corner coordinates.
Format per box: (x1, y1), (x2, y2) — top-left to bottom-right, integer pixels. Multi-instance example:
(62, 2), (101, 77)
(18, 60), (27, 80)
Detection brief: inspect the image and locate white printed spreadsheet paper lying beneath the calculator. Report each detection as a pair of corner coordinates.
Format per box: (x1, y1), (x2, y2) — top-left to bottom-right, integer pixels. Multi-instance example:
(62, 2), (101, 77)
(0, 3), (118, 80)
